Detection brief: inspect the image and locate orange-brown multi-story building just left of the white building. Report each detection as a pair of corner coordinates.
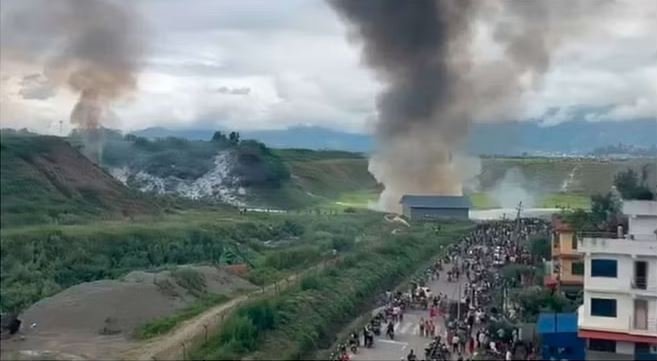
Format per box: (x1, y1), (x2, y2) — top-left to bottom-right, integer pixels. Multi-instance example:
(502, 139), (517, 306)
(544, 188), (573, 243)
(547, 215), (584, 297)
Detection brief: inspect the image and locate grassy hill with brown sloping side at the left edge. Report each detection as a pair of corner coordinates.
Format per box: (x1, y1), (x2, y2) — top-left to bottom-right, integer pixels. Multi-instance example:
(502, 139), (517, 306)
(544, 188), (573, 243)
(0, 131), (154, 227)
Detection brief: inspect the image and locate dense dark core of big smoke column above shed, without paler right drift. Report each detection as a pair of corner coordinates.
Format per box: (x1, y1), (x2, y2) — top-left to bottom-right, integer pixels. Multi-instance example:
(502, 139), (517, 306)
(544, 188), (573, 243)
(330, 0), (474, 210)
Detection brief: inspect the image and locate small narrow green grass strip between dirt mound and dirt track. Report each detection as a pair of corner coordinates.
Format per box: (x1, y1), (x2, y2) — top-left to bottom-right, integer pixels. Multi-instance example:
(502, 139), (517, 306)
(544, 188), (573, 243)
(135, 294), (229, 340)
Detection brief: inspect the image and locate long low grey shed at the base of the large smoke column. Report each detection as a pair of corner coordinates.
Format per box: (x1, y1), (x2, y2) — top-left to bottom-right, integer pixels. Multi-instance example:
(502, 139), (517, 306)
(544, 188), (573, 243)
(399, 194), (470, 221)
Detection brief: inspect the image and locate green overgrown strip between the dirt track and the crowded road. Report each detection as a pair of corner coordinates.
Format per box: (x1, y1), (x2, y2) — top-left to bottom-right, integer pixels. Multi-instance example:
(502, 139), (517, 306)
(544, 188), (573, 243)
(193, 224), (469, 359)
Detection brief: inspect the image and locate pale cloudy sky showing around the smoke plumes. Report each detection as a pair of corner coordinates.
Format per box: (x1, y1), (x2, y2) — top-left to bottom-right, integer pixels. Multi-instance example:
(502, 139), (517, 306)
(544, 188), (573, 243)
(0, 0), (657, 134)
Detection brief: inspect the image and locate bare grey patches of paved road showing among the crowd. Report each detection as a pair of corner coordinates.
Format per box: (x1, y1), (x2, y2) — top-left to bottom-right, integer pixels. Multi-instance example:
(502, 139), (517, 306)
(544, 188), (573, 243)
(350, 266), (465, 361)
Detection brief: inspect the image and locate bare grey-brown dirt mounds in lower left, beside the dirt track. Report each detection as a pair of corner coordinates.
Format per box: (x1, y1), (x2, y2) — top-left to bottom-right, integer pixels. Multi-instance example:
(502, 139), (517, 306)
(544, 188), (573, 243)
(1, 266), (255, 360)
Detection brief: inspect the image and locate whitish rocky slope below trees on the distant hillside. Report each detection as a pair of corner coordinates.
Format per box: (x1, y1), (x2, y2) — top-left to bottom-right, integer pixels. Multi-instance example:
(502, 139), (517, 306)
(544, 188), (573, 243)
(110, 151), (246, 206)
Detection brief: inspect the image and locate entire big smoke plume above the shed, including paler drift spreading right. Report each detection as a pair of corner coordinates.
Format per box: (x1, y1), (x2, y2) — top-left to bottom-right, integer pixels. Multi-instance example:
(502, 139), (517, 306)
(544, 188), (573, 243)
(328, 0), (605, 211)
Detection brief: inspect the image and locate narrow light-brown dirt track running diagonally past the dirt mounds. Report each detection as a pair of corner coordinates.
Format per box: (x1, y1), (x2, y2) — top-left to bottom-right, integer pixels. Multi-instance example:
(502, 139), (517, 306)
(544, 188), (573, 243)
(120, 260), (337, 360)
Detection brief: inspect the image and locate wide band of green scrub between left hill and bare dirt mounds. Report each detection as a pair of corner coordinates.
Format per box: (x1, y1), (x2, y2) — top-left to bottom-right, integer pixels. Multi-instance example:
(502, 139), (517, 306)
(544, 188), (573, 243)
(0, 211), (381, 311)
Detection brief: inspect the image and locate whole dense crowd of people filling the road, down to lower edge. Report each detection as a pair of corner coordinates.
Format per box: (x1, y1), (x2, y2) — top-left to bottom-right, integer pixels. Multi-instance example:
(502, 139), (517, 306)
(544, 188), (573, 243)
(328, 219), (550, 361)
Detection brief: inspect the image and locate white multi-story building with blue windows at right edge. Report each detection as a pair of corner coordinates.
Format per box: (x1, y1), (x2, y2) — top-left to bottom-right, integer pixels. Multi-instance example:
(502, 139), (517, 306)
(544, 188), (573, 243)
(578, 201), (657, 360)
